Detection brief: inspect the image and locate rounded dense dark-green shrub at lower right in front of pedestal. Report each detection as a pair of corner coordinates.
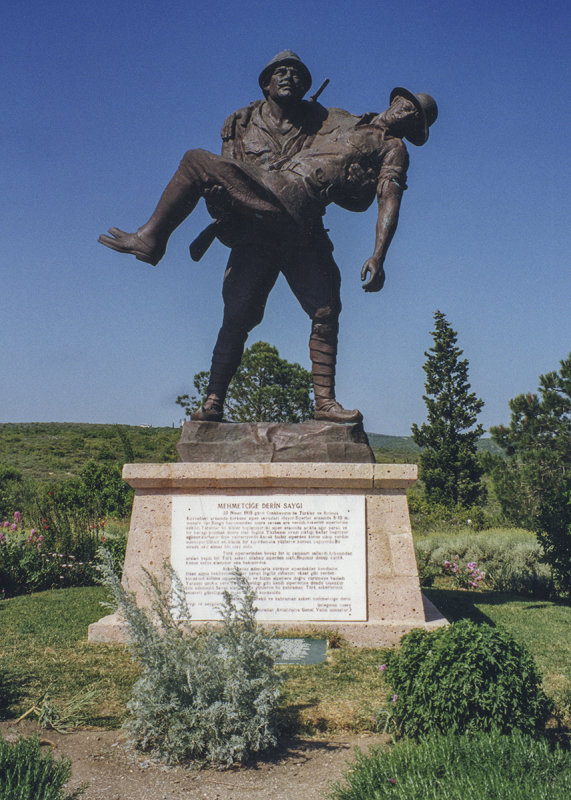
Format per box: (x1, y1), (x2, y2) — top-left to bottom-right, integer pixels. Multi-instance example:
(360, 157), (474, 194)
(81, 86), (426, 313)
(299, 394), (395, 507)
(385, 620), (551, 737)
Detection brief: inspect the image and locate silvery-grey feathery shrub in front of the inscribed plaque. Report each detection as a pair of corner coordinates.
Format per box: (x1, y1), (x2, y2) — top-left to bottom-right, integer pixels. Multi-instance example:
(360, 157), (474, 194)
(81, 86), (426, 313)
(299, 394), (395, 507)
(101, 552), (282, 766)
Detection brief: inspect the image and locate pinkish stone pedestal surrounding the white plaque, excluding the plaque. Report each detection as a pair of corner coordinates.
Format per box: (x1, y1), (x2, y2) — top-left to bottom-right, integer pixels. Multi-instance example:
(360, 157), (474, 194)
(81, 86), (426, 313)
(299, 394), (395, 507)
(89, 463), (446, 647)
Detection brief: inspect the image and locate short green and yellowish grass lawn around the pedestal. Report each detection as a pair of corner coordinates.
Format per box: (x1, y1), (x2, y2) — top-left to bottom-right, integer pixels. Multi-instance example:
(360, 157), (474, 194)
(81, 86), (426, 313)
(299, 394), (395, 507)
(0, 587), (571, 733)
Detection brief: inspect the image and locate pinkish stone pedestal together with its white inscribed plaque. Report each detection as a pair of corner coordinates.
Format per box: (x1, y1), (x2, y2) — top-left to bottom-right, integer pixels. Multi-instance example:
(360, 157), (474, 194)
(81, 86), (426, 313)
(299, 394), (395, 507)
(89, 462), (446, 646)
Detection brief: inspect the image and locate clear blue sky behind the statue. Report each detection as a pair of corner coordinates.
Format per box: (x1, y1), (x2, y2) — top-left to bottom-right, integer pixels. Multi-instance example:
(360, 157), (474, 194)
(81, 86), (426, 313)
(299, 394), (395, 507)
(0, 0), (571, 435)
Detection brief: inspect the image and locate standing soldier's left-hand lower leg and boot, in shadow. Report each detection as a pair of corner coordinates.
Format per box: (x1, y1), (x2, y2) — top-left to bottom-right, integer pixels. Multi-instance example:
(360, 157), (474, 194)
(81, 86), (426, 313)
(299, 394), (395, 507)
(190, 323), (248, 422)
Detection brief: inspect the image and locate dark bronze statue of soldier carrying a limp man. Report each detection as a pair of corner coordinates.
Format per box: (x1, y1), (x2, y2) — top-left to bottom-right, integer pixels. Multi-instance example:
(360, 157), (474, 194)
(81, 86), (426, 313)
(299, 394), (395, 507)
(99, 50), (438, 422)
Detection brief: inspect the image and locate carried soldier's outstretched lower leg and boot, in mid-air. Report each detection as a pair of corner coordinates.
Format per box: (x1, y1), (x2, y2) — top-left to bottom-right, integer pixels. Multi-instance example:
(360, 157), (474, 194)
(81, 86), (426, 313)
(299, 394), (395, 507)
(98, 164), (200, 267)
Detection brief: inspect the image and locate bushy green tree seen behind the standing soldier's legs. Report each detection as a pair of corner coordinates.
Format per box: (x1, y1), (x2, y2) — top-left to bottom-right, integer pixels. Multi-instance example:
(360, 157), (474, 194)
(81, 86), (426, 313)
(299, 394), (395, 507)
(176, 342), (313, 422)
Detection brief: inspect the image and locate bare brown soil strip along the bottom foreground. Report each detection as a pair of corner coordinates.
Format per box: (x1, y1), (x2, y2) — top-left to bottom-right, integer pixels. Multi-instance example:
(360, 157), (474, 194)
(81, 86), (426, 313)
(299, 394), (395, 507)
(0, 720), (388, 800)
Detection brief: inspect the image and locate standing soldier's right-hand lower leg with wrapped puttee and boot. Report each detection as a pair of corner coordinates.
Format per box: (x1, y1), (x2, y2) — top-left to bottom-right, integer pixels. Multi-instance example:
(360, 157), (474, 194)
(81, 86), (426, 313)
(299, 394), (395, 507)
(309, 322), (363, 423)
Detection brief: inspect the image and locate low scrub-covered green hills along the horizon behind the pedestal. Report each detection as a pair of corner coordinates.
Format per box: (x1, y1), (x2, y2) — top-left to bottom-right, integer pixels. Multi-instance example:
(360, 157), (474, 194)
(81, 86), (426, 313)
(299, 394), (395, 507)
(0, 422), (500, 480)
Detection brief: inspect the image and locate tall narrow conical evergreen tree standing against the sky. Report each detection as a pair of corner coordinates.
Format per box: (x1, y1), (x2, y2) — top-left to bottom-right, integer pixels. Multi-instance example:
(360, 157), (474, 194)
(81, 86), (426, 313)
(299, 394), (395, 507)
(412, 311), (485, 506)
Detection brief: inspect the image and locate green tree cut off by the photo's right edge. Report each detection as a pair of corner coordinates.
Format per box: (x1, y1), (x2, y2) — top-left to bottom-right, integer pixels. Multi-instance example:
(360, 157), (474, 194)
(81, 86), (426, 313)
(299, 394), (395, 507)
(489, 353), (571, 594)
